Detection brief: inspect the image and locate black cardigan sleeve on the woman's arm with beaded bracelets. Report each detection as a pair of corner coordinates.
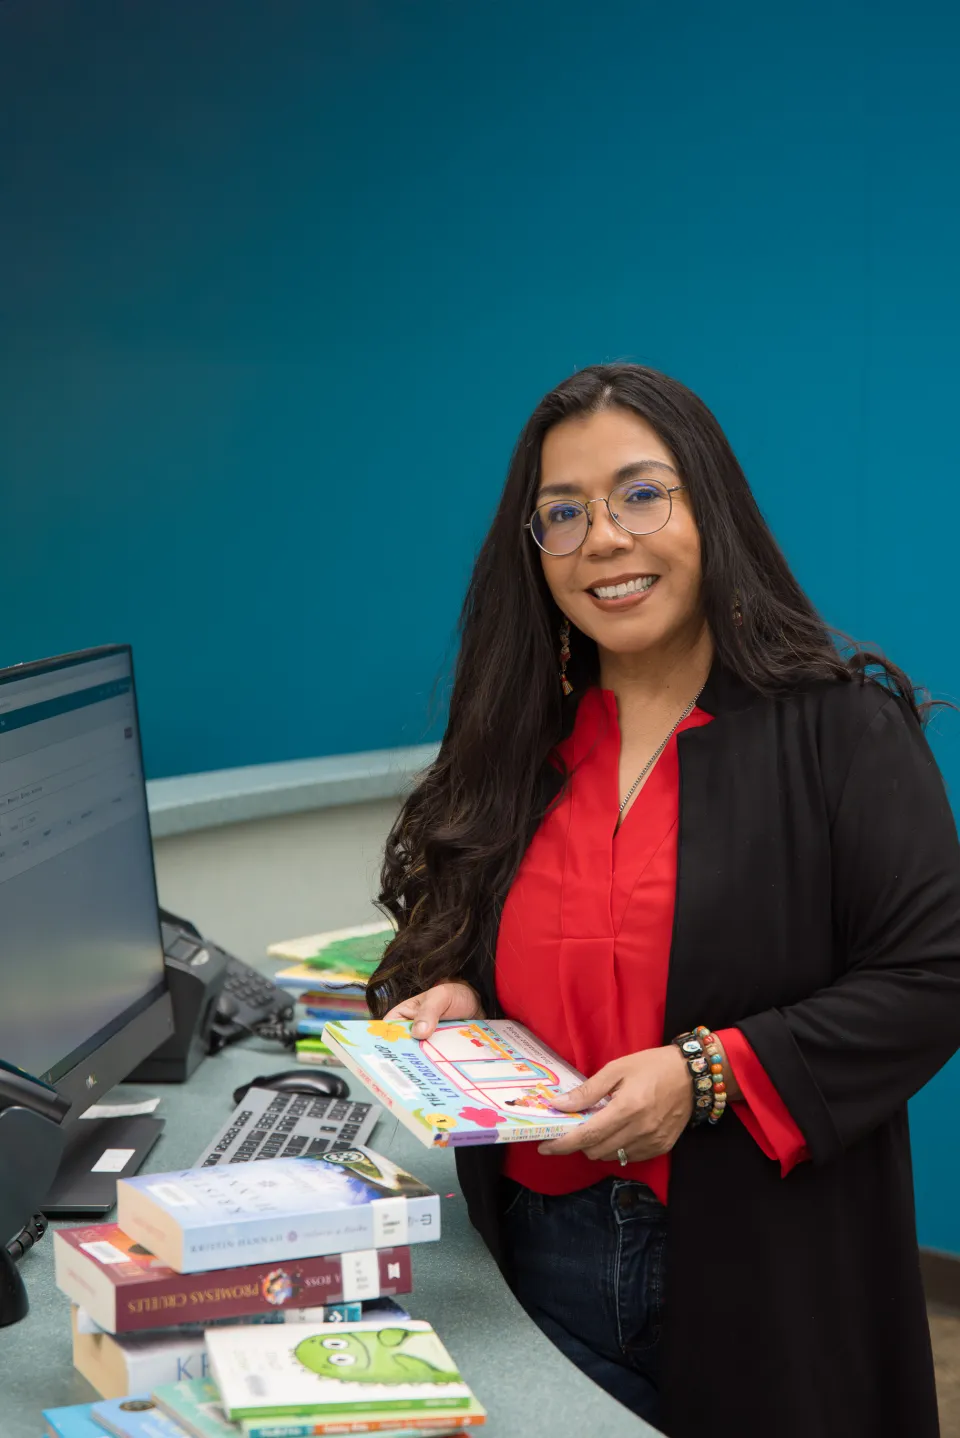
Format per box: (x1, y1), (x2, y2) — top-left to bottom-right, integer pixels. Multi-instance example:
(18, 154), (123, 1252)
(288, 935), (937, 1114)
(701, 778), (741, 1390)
(737, 696), (960, 1163)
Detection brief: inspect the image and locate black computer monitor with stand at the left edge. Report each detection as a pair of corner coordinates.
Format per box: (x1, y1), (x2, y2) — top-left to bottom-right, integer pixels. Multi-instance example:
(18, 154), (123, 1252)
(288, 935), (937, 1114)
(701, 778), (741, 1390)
(0, 644), (172, 1221)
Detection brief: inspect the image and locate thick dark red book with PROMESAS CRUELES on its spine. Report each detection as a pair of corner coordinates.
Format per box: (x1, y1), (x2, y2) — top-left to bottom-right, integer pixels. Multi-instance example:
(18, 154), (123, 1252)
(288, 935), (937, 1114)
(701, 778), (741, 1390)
(53, 1224), (412, 1333)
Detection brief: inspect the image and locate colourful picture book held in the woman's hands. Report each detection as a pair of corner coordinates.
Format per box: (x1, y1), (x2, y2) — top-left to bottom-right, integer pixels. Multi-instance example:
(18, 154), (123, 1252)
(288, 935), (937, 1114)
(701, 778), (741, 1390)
(323, 1018), (589, 1148)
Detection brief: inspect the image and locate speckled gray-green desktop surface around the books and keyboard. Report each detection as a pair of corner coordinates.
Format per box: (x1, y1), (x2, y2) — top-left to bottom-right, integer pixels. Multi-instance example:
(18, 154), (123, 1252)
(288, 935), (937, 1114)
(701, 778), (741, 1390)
(0, 1045), (655, 1438)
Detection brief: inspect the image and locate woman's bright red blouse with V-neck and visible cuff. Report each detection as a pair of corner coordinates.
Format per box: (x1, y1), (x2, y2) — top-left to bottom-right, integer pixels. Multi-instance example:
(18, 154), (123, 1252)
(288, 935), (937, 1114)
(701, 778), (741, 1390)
(496, 689), (806, 1202)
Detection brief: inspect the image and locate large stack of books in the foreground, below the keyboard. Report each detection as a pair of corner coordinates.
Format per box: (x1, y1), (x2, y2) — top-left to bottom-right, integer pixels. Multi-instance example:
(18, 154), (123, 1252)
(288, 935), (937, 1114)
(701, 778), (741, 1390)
(43, 1148), (486, 1438)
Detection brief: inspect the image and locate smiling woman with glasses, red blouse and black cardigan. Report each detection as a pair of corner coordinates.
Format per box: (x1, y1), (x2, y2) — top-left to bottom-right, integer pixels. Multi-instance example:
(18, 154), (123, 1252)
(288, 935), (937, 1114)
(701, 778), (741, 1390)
(371, 365), (960, 1438)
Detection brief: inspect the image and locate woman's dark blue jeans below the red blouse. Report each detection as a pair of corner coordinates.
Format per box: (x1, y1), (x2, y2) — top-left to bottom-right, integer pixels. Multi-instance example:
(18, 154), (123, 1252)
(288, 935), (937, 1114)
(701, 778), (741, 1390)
(502, 1178), (667, 1426)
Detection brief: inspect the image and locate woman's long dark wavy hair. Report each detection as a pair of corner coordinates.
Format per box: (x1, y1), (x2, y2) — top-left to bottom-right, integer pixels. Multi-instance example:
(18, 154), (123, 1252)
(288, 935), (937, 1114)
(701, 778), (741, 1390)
(368, 364), (928, 1014)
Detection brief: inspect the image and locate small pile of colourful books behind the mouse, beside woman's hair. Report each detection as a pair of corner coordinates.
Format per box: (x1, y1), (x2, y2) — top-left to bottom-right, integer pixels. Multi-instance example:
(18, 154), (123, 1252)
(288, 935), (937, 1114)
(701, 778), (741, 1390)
(267, 920), (395, 1067)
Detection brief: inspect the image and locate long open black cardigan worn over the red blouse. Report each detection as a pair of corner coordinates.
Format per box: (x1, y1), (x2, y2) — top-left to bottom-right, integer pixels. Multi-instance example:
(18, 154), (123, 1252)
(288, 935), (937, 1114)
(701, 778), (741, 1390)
(457, 664), (960, 1438)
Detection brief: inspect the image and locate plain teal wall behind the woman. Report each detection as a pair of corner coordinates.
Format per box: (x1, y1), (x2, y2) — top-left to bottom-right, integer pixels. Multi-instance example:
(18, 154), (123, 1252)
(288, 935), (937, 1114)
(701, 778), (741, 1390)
(0, 0), (960, 1251)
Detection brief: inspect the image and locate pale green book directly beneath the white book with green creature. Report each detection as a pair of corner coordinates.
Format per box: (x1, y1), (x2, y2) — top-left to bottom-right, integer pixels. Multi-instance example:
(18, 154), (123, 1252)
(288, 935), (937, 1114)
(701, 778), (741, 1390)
(152, 1379), (487, 1438)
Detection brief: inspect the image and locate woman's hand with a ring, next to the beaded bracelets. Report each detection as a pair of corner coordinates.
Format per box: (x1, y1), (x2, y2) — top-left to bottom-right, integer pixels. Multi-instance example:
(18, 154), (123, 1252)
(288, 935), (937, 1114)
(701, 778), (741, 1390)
(537, 1044), (693, 1163)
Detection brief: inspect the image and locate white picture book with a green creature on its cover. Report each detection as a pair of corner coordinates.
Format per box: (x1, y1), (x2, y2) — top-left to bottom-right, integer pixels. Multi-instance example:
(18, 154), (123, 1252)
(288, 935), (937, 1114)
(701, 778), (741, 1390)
(207, 1319), (473, 1426)
